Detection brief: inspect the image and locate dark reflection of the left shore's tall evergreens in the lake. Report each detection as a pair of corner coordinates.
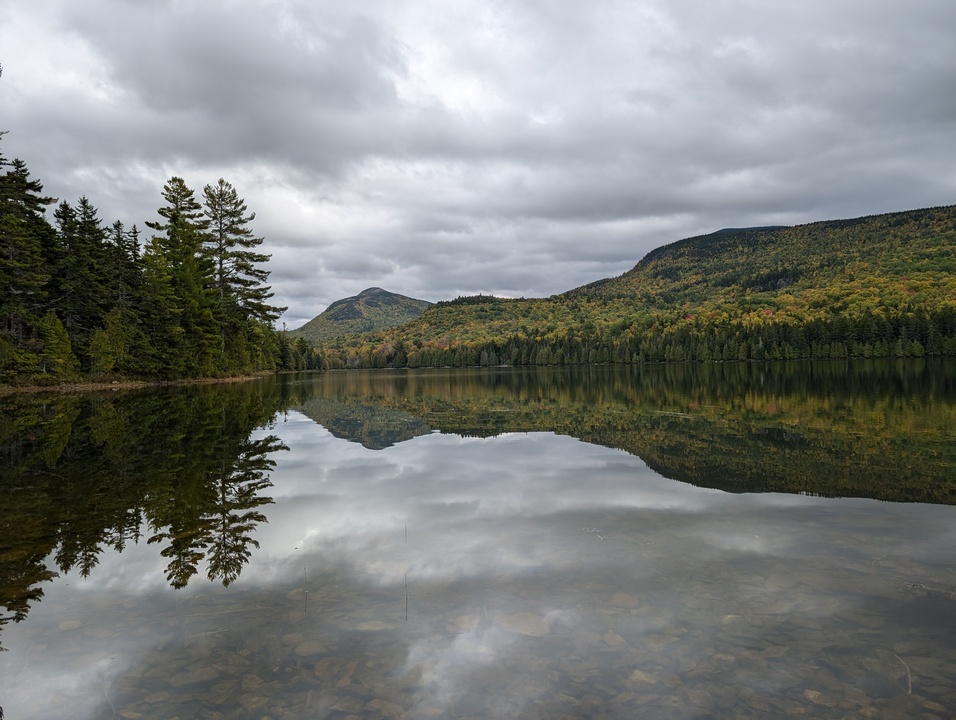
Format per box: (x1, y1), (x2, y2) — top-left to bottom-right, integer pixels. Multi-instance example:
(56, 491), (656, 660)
(0, 385), (288, 648)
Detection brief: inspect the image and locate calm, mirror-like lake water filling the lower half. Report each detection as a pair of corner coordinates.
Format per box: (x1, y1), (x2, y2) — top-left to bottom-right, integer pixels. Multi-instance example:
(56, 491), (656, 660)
(0, 361), (956, 720)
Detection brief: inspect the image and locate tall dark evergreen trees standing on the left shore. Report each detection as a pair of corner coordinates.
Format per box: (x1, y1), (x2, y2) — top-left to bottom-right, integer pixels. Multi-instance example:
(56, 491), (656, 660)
(0, 133), (319, 385)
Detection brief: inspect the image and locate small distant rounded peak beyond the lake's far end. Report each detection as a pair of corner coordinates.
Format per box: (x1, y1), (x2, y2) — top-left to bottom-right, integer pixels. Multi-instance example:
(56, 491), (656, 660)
(290, 288), (431, 342)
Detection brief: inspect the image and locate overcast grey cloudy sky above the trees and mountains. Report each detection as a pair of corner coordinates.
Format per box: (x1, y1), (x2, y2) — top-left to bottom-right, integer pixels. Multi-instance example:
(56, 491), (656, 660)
(0, 0), (956, 329)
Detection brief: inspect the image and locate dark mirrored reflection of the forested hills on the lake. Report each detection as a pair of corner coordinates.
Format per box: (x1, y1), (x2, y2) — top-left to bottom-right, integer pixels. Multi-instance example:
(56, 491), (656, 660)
(287, 362), (956, 503)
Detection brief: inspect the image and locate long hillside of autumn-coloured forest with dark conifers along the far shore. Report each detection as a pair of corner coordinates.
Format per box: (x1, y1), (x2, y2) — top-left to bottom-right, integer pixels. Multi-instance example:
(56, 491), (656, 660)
(326, 206), (956, 367)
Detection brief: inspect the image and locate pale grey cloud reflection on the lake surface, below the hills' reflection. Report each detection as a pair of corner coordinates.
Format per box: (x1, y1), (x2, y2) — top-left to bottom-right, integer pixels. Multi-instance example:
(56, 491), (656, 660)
(0, 412), (956, 718)
